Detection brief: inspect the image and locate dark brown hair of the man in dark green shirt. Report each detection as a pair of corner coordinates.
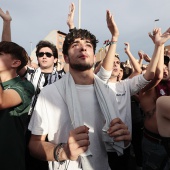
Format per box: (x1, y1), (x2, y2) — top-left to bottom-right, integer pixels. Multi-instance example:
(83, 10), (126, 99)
(0, 41), (28, 71)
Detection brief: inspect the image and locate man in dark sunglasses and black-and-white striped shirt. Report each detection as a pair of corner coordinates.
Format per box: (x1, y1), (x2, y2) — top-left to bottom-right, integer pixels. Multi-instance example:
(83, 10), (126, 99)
(22, 40), (65, 115)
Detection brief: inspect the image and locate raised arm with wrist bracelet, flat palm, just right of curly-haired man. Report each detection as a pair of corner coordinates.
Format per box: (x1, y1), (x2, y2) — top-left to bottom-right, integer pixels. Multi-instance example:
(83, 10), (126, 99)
(102, 10), (119, 71)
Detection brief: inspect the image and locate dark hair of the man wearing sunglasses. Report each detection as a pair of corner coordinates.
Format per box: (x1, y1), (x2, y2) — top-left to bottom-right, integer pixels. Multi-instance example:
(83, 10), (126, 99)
(35, 40), (58, 58)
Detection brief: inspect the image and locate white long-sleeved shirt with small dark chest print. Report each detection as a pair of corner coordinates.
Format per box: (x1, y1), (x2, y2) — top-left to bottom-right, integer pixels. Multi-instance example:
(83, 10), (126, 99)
(108, 74), (150, 132)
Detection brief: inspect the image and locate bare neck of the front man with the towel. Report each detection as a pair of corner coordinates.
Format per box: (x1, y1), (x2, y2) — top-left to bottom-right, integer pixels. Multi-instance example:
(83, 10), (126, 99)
(69, 69), (94, 85)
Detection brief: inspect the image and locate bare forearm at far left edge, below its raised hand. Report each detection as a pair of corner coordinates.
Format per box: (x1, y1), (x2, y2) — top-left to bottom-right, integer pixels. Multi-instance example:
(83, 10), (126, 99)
(2, 21), (11, 41)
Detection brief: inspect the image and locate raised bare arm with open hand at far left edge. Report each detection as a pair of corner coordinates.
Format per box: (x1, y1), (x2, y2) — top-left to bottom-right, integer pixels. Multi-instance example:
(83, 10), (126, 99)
(0, 8), (12, 41)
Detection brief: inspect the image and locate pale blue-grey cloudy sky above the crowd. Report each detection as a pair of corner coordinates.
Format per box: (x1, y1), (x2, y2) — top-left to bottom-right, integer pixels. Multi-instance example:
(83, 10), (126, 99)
(0, 0), (170, 61)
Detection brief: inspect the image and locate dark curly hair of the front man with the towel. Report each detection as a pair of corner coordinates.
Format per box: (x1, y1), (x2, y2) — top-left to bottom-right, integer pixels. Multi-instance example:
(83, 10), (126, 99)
(63, 29), (98, 55)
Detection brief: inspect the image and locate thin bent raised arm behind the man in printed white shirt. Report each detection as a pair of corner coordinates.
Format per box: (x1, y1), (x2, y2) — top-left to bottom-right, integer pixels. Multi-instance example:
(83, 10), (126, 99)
(124, 42), (142, 78)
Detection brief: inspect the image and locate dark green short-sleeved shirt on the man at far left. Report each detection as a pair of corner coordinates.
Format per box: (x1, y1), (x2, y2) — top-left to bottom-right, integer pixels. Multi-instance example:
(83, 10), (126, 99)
(0, 77), (34, 170)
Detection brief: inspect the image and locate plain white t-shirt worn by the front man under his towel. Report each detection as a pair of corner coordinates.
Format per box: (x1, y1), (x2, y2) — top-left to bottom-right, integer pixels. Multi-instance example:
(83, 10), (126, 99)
(29, 81), (109, 170)
